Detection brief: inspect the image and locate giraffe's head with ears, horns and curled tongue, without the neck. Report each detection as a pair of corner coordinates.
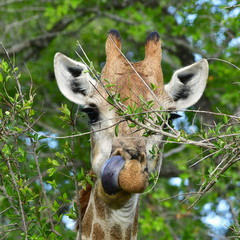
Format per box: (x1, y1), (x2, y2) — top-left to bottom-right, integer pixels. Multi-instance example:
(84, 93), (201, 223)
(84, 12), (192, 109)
(54, 30), (208, 212)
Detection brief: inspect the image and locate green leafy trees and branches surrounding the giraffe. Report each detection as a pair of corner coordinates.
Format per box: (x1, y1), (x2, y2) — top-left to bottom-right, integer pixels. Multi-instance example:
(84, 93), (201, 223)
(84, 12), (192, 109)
(0, 0), (240, 239)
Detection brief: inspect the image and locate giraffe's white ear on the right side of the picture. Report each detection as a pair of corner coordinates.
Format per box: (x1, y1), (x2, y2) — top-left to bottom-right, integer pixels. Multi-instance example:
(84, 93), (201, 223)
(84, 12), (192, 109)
(165, 59), (208, 110)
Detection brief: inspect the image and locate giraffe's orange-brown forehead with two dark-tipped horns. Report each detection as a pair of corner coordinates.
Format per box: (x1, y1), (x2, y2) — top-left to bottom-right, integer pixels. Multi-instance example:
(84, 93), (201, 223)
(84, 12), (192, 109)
(101, 31), (172, 109)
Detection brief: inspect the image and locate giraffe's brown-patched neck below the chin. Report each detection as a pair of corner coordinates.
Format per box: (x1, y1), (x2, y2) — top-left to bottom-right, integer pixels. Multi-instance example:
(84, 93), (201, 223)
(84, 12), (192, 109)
(82, 183), (139, 240)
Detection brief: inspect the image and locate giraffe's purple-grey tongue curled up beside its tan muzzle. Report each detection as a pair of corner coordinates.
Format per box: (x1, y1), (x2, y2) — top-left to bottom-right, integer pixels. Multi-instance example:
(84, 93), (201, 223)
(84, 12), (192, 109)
(101, 155), (125, 195)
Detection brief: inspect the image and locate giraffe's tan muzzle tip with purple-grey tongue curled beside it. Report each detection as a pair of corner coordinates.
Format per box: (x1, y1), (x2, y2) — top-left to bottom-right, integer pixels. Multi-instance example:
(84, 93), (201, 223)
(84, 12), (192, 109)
(101, 154), (148, 195)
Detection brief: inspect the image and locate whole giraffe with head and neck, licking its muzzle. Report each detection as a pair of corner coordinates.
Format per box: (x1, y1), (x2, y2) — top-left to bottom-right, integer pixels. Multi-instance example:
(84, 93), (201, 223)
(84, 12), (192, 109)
(54, 30), (208, 240)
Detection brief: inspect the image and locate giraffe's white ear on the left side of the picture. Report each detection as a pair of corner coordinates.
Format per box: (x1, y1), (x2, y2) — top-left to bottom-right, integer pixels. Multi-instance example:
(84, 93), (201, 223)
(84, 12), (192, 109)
(54, 53), (96, 105)
